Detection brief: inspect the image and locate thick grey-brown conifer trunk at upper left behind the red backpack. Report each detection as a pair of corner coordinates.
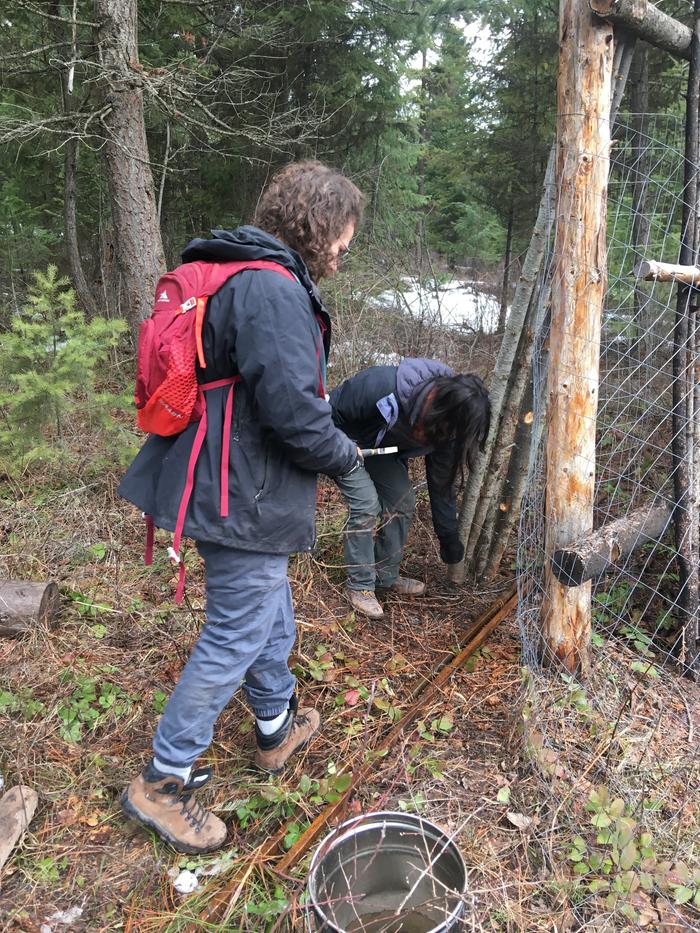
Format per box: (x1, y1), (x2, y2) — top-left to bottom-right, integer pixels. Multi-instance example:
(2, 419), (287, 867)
(95, 0), (165, 331)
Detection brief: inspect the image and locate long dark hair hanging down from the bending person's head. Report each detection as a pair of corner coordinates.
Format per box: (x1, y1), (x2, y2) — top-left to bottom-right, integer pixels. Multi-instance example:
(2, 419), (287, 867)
(423, 374), (491, 488)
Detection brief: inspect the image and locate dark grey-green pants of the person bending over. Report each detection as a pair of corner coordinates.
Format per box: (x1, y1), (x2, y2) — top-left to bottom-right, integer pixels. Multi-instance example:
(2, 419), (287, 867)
(336, 455), (416, 590)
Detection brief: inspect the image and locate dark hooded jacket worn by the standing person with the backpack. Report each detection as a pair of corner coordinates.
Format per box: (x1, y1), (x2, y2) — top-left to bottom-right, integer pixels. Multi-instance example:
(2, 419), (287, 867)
(119, 226), (357, 554)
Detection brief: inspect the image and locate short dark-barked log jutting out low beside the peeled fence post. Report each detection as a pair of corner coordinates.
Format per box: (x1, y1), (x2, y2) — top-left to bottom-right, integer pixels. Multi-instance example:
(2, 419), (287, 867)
(552, 503), (673, 586)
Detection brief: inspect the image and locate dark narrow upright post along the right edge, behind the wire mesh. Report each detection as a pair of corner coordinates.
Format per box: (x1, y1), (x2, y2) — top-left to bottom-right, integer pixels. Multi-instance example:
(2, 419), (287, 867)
(672, 0), (700, 672)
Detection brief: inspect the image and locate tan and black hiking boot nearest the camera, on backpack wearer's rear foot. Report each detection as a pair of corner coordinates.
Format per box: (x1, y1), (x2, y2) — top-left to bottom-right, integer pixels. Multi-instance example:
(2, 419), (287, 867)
(120, 762), (226, 854)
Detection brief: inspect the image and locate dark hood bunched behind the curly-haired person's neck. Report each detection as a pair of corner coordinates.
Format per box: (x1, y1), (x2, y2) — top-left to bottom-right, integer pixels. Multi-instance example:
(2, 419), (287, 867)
(182, 225), (316, 292)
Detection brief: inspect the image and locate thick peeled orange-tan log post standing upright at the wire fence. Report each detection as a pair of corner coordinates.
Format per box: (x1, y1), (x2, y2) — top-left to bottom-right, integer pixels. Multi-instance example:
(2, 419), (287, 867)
(541, 0), (613, 675)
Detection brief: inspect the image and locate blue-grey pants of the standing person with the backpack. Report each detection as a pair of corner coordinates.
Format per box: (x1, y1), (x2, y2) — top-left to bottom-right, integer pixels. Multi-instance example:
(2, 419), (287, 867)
(153, 541), (296, 767)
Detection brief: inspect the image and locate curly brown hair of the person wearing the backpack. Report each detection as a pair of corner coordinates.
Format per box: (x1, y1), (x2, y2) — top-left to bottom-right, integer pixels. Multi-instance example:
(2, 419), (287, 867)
(255, 160), (364, 280)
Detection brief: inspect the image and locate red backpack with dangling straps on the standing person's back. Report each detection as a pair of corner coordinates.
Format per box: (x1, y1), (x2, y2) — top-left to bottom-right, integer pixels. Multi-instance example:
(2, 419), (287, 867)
(134, 259), (297, 603)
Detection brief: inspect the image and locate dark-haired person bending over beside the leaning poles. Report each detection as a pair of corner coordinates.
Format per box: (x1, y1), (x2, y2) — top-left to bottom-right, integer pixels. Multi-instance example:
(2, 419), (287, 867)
(330, 359), (491, 619)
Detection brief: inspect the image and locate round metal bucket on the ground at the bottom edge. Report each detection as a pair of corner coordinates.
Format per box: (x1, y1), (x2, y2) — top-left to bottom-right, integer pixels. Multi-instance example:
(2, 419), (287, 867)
(307, 813), (467, 933)
